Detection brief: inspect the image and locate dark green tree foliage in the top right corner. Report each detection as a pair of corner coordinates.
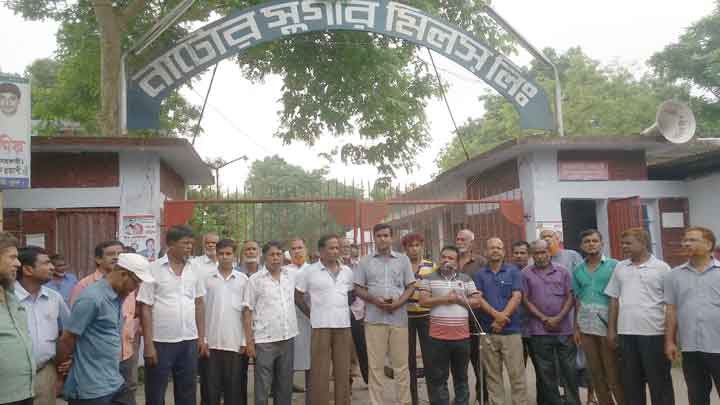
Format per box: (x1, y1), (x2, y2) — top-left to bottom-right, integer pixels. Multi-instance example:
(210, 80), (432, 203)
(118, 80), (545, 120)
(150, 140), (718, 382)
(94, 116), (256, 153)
(650, 1), (720, 135)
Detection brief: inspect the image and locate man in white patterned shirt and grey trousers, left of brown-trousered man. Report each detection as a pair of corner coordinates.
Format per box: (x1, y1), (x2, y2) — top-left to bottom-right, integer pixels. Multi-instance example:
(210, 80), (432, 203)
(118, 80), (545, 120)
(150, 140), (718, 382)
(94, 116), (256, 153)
(243, 241), (298, 405)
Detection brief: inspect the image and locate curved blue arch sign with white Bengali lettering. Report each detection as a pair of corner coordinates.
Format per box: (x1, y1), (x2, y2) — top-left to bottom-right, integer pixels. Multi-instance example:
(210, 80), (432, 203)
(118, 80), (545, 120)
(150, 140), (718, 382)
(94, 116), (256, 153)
(126, 0), (555, 131)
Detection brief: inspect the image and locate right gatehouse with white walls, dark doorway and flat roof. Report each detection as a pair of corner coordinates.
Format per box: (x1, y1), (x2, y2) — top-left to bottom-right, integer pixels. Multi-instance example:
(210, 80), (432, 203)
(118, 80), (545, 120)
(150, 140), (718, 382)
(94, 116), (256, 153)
(400, 135), (720, 264)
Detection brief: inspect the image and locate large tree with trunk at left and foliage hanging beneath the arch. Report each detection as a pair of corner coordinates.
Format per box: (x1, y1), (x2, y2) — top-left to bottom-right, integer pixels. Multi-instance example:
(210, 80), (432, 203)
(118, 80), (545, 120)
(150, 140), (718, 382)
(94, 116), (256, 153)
(9, 0), (512, 176)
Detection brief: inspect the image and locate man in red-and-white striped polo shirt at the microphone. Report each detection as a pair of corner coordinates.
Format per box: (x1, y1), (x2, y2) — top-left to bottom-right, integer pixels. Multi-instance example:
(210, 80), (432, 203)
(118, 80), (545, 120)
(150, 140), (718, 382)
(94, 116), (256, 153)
(420, 246), (480, 405)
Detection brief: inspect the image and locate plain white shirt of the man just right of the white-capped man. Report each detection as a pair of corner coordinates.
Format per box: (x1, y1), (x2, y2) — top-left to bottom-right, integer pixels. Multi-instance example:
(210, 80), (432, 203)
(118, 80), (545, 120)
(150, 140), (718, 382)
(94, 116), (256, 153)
(137, 256), (205, 343)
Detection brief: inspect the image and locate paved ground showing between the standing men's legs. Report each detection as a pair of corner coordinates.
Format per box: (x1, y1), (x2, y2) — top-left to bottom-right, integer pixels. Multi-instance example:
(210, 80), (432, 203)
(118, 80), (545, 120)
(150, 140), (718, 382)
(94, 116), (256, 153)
(105, 365), (720, 405)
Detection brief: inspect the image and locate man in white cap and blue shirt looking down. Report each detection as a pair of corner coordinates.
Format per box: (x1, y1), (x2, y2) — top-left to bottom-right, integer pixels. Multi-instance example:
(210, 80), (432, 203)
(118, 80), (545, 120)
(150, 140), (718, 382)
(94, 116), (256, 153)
(57, 253), (154, 405)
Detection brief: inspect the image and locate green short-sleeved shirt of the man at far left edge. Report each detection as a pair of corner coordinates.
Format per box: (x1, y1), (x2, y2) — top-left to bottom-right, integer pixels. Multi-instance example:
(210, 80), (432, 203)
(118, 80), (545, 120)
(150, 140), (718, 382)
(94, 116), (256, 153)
(0, 290), (35, 404)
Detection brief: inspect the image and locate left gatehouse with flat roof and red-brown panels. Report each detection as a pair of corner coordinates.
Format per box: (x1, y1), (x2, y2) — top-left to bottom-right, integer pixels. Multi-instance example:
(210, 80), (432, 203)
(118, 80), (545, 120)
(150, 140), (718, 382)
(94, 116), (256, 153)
(3, 136), (214, 276)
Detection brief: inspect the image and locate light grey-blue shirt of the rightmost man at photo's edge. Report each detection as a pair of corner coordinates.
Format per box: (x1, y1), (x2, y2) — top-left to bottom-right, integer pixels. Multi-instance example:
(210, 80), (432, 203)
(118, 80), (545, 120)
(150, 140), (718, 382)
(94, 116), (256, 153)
(665, 260), (720, 353)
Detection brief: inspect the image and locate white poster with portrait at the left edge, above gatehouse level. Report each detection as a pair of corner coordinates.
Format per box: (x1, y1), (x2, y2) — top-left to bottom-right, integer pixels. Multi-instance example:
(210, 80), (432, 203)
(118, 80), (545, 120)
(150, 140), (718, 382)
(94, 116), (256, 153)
(0, 74), (32, 190)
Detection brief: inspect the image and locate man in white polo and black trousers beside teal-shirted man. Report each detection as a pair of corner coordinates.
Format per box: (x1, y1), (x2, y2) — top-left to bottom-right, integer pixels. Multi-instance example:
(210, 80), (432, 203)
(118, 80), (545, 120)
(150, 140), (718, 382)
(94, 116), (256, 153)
(605, 228), (675, 405)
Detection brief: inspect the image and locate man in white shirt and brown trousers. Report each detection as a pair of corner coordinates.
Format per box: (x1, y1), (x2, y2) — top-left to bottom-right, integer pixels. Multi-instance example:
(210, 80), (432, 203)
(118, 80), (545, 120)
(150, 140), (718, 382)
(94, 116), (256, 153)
(295, 235), (354, 405)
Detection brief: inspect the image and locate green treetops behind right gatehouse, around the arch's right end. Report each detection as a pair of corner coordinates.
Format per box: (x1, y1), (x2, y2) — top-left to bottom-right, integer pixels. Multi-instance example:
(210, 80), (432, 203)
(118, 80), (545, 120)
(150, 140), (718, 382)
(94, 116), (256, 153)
(437, 48), (689, 170)
